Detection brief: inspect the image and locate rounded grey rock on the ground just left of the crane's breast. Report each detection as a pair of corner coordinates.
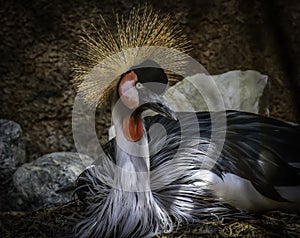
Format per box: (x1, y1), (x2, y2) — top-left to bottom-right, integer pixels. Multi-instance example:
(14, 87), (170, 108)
(13, 152), (93, 210)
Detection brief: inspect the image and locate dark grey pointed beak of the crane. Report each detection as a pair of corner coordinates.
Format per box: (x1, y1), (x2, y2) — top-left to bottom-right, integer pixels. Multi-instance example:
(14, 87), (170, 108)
(134, 87), (177, 120)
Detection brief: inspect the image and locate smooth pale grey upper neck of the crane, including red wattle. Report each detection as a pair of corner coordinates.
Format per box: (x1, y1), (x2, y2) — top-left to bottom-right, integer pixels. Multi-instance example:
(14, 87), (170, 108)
(114, 108), (150, 192)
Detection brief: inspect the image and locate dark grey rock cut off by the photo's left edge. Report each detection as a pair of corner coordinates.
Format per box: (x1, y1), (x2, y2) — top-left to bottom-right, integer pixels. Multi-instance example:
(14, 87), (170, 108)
(0, 119), (25, 211)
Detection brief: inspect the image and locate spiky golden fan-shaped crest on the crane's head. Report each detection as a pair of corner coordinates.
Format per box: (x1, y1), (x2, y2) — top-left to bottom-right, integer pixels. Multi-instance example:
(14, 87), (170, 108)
(74, 6), (190, 106)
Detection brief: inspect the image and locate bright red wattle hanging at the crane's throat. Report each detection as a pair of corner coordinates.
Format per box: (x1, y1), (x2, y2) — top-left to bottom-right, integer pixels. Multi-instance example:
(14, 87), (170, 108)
(123, 115), (144, 142)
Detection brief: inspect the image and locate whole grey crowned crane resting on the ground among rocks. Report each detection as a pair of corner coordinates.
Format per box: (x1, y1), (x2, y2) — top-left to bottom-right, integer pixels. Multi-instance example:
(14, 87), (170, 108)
(76, 5), (300, 237)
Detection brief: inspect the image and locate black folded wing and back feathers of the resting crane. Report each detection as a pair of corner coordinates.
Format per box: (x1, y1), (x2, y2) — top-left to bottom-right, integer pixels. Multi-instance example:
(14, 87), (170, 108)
(145, 111), (300, 201)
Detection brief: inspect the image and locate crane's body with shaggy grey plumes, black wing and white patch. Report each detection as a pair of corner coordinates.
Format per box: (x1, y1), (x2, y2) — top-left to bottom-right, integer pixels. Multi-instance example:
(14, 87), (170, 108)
(78, 111), (300, 237)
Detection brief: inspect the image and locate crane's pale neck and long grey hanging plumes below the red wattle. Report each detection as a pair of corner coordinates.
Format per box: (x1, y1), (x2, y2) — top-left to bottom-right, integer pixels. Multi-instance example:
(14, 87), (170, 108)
(104, 109), (172, 237)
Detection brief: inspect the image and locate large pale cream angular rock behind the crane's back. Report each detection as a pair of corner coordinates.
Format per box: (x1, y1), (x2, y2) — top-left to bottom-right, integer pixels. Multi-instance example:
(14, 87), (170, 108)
(165, 70), (269, 115)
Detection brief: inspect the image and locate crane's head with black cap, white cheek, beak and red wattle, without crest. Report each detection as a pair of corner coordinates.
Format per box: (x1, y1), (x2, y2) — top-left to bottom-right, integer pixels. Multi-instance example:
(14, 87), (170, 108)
(117, 60), (176, 142)
